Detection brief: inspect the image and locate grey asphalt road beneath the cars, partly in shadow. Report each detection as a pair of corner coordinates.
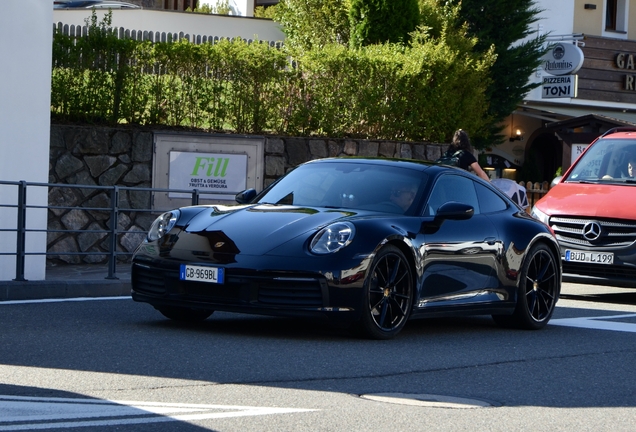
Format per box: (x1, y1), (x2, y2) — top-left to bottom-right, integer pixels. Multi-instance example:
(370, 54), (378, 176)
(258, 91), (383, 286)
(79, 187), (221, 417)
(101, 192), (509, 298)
(0, 283), (636, 432)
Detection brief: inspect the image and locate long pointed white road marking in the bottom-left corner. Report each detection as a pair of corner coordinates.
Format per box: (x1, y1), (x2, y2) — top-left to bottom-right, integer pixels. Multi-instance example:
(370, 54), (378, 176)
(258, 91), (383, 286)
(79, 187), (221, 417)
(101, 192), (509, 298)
(0, 395), (316, 431)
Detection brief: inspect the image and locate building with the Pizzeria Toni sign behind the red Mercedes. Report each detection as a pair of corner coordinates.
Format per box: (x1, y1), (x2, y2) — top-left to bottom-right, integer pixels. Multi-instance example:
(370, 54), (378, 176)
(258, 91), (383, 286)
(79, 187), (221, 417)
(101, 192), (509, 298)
(492, 0), (636, 181)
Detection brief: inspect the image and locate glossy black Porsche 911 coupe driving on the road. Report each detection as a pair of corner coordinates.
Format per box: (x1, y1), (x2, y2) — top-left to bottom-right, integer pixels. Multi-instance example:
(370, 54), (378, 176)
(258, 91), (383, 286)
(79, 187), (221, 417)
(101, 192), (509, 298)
(132, 158), (561, 339)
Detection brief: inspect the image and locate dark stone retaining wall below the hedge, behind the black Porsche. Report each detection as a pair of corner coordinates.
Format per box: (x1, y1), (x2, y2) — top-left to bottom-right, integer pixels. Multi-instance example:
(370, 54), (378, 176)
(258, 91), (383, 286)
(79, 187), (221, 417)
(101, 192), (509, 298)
(48, 124), (445, 264)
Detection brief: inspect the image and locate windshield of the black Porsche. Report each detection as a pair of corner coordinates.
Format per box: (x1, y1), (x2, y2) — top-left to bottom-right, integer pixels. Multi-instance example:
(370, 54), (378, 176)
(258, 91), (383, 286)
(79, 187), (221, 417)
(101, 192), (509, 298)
(258, 162), (427, 213)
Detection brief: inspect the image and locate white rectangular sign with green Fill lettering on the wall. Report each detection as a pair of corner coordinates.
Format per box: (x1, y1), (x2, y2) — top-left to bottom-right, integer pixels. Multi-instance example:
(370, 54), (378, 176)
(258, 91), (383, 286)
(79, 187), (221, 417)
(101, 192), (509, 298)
(168, 151), (247, 199)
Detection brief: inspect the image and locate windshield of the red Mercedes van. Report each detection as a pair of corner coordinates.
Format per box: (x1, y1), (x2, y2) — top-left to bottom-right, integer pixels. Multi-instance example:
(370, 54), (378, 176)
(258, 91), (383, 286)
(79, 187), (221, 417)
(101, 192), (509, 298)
(565, 139), (636, 183)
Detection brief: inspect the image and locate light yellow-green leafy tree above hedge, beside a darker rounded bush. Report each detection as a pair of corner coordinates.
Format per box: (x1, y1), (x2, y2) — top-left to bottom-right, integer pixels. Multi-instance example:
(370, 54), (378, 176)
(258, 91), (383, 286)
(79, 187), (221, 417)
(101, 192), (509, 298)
(268, 0), (350, 49)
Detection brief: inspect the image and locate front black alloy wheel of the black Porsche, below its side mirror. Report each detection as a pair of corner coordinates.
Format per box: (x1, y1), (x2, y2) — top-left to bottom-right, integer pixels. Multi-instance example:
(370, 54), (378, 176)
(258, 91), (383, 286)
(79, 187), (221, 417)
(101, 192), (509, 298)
(358, 245), (413, 339)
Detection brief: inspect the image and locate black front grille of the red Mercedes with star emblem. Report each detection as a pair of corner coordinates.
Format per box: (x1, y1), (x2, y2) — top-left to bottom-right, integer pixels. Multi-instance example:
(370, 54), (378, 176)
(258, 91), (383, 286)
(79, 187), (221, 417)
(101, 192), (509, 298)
(550, 217), (636, 248)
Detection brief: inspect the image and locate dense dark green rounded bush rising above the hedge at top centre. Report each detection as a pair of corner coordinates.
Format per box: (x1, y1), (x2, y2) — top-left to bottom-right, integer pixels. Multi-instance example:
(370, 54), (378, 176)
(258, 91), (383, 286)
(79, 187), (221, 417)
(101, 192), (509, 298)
(349, 0), (420, 48)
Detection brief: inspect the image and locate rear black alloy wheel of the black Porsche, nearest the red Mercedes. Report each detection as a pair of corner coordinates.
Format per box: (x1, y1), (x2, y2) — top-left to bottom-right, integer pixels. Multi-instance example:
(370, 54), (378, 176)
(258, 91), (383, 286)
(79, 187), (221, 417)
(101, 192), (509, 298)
(493, 244), (561, 330)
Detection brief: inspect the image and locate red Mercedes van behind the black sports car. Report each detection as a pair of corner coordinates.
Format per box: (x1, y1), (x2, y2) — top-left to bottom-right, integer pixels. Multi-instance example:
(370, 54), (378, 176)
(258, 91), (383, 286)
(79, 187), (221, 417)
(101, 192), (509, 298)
(532, 127), (636, 287)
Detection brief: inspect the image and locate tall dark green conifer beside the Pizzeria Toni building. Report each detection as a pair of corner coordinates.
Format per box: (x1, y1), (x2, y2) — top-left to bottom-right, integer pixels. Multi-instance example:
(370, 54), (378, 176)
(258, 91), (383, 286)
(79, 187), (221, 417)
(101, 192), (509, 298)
(448, 0), (545, 148)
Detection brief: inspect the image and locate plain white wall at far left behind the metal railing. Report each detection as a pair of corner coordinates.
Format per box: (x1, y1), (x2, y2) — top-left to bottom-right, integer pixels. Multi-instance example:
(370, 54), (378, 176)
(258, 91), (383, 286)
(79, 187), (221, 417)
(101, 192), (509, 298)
(0, 0), (53, 280)
